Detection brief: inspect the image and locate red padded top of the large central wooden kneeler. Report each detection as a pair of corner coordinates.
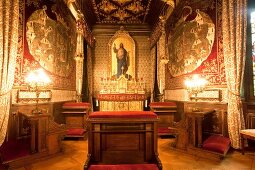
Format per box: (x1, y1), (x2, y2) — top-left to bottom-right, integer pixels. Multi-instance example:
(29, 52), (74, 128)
(89, 111), (157, 119)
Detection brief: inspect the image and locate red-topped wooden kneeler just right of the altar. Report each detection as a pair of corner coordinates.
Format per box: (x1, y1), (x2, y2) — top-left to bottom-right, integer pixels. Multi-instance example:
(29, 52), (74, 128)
(150, 102), (177, 136)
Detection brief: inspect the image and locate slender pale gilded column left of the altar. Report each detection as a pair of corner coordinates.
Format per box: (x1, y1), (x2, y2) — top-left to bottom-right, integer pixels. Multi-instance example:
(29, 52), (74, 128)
(75, 14), (84, 102)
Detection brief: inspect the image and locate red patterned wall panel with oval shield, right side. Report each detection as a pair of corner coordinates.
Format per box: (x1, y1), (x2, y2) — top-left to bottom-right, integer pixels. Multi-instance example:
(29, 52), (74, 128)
(165, 0), (226, 90)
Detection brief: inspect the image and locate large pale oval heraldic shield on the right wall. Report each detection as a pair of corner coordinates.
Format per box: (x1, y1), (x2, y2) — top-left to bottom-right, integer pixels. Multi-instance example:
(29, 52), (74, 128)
(168, 6), (215, 77)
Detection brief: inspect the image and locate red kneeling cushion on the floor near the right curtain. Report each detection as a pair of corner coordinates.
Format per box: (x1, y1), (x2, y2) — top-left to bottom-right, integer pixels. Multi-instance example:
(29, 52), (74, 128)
(202, 135), (230, 155)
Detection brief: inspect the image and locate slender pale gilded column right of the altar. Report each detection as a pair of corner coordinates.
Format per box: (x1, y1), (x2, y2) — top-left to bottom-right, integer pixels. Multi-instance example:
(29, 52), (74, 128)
(158, 16), (169, 100)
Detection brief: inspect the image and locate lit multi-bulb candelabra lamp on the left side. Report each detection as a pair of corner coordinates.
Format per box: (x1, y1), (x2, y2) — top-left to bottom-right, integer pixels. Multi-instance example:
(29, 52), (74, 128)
(25, 68), (51, 114)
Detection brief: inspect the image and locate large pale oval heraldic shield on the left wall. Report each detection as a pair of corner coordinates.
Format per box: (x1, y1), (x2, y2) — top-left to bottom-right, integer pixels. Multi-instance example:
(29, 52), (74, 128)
(26, 6), (76, 77)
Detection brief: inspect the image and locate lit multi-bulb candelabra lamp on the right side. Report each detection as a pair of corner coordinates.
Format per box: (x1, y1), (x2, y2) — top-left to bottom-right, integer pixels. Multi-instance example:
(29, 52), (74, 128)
(185, 74), (207, 111)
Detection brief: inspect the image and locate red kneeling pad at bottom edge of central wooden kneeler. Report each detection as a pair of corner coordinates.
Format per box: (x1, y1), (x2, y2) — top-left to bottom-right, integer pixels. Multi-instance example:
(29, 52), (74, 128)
(89, 164), (158, 170)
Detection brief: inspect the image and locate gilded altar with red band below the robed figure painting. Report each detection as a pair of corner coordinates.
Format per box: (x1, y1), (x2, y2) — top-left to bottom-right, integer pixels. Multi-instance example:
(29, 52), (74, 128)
(97, 75), (147, 111)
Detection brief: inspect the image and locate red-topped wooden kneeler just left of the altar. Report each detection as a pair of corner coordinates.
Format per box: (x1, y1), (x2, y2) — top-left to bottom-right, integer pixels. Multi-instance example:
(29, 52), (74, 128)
(62, 102), (91, 137)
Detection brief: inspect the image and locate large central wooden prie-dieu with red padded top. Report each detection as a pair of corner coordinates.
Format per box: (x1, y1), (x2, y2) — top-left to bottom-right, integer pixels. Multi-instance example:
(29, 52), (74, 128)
(84, 111), (162, 169)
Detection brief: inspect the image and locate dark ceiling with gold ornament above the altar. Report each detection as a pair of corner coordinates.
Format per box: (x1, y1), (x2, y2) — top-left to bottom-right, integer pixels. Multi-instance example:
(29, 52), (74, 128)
(78, 0), (166, 26)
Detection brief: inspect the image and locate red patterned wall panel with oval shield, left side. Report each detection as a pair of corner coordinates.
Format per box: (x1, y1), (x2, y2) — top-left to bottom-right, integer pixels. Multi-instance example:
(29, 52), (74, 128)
(14, 0), (76, 90)
